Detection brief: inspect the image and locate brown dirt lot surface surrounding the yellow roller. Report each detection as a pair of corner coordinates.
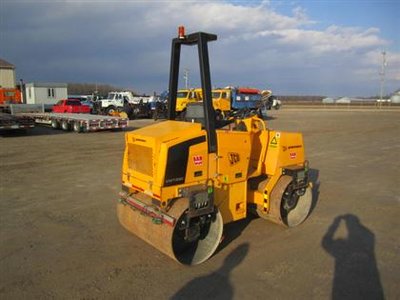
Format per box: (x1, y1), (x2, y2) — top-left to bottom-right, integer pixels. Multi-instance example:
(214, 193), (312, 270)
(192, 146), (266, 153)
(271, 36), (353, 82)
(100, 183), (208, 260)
(0, 109), (400, 299)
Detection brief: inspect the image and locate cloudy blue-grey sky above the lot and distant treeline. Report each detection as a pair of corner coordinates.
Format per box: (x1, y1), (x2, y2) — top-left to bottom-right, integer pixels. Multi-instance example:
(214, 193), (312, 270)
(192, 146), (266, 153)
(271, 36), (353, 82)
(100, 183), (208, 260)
(0, 0), (400, 96)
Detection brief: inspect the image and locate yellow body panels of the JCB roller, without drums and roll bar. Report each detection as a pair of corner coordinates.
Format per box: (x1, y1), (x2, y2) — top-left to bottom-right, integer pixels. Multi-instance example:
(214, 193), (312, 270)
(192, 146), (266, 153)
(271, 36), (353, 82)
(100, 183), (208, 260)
(122, 117), (304, 218)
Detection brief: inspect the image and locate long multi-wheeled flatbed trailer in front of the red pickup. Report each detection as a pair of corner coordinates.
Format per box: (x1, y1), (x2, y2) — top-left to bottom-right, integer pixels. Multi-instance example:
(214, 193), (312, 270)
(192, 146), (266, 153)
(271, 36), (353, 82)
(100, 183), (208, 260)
(19, 112), (128, 132)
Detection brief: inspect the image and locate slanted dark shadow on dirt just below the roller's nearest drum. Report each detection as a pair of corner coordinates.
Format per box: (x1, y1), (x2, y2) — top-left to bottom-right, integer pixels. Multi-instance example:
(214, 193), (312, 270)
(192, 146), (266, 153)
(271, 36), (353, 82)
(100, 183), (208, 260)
(170, 243), (249, 300)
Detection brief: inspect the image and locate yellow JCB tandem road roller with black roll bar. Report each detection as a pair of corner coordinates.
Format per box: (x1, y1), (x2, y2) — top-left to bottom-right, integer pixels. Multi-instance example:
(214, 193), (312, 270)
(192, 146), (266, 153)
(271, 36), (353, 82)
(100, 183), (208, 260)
(117, 31), (312, 265)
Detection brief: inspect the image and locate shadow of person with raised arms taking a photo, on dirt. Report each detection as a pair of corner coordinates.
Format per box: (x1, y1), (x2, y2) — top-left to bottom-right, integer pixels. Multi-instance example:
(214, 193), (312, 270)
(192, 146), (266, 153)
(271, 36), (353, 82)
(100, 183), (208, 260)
(321, 214), (384, 300)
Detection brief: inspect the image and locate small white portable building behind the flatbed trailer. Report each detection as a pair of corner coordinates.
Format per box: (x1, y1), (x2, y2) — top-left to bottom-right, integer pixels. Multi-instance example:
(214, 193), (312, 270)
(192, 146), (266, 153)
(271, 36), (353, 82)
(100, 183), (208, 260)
(25, 82), (68, 104)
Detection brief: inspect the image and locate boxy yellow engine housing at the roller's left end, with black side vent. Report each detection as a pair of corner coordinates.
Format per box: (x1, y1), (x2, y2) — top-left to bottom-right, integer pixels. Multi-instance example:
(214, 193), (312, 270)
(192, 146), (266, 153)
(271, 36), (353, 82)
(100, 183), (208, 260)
(122, 121), (208, 206)
